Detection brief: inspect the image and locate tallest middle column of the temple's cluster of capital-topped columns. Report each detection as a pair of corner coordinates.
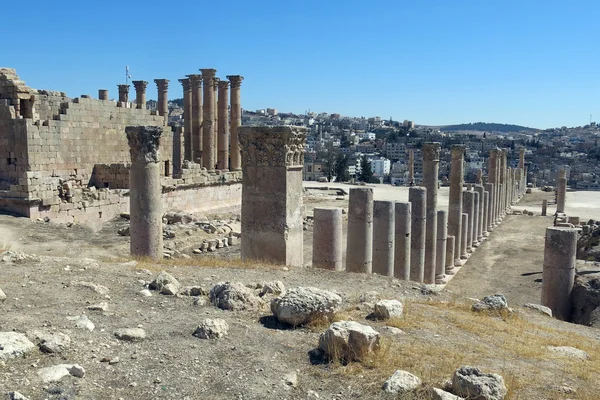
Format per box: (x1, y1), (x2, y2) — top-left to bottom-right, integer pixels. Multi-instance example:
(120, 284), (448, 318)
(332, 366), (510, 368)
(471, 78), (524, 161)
(200, 69), (217, 171)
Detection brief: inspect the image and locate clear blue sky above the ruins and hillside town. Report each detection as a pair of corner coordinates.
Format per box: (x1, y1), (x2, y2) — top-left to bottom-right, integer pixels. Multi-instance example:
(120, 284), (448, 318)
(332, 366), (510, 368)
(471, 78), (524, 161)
(0, 0), (600, 128)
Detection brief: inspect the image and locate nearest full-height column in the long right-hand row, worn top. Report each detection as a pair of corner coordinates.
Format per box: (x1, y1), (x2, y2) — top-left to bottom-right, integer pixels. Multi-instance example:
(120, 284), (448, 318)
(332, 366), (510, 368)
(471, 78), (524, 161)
(421, 143), (441, 283)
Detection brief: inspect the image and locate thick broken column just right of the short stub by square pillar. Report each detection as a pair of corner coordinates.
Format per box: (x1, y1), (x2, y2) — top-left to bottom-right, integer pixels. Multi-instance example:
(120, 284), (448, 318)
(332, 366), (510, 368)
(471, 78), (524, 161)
(344, 188), (373, 274)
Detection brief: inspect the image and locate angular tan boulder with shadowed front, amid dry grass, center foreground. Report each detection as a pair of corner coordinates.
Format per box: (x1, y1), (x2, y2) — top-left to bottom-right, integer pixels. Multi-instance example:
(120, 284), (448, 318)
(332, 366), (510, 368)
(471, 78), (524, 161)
(319, 321), (379, 361)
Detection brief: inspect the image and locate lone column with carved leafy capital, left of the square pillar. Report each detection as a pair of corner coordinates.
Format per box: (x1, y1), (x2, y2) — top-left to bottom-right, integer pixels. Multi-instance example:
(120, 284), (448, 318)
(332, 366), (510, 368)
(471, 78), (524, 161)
(125, 126), (163, 260)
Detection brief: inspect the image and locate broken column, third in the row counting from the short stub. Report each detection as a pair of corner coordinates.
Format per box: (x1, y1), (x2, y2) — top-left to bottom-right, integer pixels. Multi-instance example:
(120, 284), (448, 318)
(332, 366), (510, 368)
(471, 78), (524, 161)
(373, 201), (396, 277)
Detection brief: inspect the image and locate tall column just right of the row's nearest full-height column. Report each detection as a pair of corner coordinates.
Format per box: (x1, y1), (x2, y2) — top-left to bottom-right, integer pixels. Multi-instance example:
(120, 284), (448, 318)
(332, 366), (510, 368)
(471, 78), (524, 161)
(448, 145), (465, 266)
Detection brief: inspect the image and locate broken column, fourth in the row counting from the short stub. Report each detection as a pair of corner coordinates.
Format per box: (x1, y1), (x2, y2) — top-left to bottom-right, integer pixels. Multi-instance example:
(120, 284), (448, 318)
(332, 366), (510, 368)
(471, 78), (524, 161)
(394, 203), (412, 281)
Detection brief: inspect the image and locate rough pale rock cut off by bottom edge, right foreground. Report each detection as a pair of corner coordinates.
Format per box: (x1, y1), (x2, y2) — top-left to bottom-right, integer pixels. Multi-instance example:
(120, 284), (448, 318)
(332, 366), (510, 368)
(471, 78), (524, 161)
(452, 366), (508, 400)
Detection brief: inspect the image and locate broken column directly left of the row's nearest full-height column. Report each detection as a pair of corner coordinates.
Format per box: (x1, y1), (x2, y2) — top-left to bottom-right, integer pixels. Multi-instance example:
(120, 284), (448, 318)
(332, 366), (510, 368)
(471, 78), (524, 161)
(408, 186), (427, 282)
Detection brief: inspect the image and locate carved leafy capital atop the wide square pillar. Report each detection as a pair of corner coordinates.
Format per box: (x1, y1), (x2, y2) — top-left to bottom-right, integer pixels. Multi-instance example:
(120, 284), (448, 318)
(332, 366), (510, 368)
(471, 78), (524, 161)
(238, 126), (307, 168)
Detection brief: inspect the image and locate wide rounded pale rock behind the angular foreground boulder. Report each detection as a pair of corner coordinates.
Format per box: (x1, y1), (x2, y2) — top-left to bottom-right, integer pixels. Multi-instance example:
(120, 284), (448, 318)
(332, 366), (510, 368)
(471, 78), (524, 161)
(271, 287), (342, 326)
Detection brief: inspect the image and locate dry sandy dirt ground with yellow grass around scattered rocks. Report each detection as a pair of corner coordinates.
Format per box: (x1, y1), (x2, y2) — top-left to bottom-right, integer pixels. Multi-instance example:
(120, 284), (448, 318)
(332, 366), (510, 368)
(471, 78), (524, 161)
(0, 188), (600, 400)
